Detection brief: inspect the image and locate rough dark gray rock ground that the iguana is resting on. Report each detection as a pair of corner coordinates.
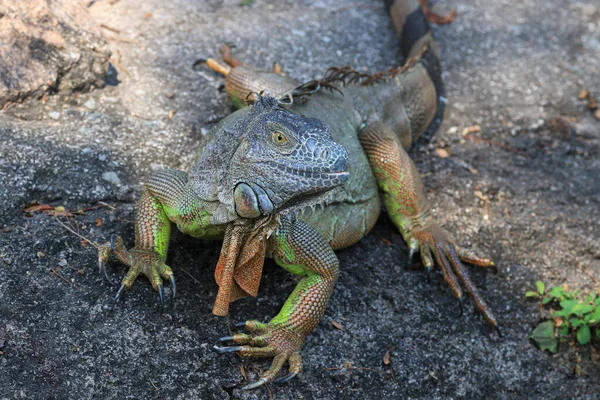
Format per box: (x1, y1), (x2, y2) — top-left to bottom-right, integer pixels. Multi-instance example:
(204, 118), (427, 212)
(0, 0), (600, 399)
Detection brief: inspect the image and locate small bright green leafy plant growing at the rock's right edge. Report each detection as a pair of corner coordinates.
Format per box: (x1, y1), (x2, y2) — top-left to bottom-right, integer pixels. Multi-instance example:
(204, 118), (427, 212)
(525, 281), (600, 353)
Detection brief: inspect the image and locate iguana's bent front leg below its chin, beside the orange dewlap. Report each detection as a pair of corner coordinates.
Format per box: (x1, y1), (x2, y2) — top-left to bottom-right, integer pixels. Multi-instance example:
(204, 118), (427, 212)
(215, 217), (339, 389)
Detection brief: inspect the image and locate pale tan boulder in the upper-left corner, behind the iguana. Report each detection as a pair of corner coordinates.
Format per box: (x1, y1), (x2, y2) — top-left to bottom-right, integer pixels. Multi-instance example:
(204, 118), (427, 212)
(0, 0), (110, 108)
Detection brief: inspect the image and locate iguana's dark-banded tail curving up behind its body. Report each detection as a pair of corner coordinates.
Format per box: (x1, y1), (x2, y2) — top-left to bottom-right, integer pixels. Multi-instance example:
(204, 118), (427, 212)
(385, 0), (446, 143)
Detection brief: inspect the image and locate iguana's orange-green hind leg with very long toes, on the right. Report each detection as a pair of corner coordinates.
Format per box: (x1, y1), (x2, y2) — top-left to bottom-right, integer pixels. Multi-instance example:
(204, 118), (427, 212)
(359, 123), (497, 328)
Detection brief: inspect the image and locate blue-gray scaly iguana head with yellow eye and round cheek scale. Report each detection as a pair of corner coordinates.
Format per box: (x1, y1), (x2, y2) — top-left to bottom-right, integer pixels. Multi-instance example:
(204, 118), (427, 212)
(190, 96), (348, 222)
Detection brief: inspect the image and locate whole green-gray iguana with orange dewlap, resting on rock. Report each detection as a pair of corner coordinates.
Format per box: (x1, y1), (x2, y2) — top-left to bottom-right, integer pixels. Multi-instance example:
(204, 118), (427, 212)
(98, 0), (497, 389)
